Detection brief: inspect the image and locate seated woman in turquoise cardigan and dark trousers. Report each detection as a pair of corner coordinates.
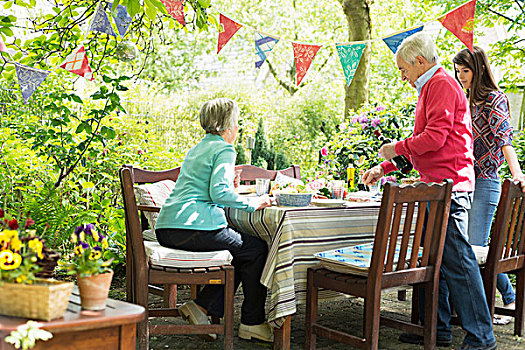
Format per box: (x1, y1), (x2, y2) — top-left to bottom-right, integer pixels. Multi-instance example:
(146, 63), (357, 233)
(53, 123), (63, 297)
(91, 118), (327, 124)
(155, 98), (273, 342)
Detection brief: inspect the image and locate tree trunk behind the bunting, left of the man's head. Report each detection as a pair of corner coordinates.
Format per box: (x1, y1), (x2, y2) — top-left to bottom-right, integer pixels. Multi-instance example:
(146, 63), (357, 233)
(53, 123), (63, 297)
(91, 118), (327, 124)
(339, 0), (372, 119)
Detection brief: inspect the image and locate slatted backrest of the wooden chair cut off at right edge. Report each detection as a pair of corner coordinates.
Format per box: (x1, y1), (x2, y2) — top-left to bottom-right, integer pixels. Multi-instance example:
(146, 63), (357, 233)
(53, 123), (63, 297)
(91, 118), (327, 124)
(486, 179), (525, 275)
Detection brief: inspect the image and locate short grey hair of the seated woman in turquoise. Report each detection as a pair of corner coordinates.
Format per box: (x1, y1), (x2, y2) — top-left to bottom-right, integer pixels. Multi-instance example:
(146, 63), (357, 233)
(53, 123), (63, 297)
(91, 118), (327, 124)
(199, 97), (239, 134)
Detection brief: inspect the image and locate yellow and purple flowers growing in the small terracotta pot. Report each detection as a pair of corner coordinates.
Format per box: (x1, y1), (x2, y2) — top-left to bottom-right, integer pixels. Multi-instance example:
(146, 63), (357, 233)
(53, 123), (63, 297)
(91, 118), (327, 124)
(63, 224), (113, 277)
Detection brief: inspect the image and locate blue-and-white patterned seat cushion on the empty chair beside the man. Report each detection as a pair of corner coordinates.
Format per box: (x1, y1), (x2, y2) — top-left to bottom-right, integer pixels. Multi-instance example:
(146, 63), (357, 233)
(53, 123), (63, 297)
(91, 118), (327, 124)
(314, 243), (423, 276)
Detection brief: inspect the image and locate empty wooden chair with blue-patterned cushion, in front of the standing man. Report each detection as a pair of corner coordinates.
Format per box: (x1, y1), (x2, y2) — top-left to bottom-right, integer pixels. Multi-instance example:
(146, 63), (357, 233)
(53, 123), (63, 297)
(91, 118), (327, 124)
(305, 180), (452, 349)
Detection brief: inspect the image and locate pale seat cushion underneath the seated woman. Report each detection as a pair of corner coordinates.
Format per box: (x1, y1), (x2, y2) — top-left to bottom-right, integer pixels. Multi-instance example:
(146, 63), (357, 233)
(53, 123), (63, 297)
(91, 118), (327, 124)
(144, 241), (233, 268)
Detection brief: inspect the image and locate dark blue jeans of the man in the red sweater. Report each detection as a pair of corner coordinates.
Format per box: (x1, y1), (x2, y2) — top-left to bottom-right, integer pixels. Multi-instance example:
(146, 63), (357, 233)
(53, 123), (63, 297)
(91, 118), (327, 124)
(419, 192), (496, 346)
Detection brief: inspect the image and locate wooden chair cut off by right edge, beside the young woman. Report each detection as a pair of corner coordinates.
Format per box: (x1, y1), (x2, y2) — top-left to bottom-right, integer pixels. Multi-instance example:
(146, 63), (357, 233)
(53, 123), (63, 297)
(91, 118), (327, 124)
(480, 179), (525, 336)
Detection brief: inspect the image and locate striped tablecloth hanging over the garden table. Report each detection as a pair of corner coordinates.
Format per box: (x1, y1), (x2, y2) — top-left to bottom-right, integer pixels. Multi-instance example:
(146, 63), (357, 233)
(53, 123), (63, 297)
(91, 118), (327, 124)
(225, 202), (380, 327)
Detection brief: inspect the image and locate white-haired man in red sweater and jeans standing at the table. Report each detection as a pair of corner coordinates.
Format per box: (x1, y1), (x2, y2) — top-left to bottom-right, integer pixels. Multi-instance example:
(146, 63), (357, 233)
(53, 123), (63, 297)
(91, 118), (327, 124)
(363, 33), (497, 350)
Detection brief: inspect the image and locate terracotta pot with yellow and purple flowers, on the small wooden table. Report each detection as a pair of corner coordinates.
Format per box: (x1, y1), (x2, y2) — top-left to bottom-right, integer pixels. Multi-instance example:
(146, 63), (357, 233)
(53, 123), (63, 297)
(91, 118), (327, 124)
(64, 224), (113, 310)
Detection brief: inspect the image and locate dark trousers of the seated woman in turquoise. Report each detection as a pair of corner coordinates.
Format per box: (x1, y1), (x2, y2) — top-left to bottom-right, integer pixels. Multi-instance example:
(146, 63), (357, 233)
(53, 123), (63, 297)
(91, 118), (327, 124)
(155, 227), (268, 325)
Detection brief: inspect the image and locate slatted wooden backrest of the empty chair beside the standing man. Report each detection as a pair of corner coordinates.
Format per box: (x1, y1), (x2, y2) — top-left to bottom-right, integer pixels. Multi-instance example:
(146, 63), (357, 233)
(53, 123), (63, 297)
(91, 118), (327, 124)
(368, 180), (453, 282)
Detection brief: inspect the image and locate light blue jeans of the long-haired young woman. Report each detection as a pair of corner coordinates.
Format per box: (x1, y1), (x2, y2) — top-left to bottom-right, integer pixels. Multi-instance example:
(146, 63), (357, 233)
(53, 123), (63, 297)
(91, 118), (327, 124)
(468, 179), (516, 305)
